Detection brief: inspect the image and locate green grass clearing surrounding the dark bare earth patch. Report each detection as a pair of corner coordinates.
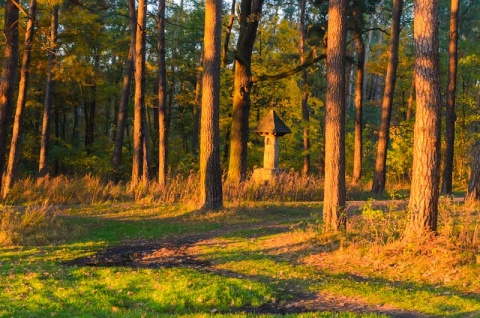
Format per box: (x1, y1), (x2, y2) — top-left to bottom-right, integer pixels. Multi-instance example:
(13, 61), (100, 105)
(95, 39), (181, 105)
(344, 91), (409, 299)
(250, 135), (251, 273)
(0, 203), (480, 317)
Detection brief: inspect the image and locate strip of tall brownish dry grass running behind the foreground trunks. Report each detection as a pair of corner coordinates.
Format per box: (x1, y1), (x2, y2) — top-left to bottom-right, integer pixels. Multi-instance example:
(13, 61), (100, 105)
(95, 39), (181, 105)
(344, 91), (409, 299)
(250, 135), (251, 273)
(4, 171), (398, 206)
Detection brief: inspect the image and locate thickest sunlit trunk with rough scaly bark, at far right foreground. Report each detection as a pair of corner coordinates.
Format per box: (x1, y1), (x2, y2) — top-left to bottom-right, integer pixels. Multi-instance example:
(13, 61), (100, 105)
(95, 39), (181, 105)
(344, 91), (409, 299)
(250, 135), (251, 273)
(406, 0), (441, 238)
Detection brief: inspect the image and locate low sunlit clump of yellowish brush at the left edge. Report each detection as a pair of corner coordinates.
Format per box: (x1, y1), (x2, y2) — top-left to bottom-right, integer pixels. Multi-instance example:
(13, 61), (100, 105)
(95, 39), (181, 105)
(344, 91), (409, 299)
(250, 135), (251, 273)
(0, 205), (80, 247)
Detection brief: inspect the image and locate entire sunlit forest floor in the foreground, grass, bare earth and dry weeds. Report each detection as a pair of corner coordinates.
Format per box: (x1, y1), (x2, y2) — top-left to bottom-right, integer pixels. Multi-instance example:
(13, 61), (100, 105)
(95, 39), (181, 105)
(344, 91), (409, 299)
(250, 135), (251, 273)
(0, 201), (480, 317)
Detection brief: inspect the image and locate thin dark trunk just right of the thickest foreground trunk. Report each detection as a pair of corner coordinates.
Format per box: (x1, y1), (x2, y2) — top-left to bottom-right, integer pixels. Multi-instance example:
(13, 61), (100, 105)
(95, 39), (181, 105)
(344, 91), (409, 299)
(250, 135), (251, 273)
(442, 0), (459, 194)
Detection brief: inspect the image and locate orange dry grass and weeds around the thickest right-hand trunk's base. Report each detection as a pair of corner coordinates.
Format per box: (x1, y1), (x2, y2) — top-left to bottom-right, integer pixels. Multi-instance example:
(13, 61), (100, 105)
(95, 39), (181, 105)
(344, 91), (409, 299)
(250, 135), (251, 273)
(302, 198), (480, 293)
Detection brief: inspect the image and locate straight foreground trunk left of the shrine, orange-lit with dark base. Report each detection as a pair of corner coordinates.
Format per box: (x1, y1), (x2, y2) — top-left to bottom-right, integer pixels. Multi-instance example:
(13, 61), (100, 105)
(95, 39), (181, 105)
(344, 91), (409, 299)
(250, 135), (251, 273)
(200, 0), (223, 210)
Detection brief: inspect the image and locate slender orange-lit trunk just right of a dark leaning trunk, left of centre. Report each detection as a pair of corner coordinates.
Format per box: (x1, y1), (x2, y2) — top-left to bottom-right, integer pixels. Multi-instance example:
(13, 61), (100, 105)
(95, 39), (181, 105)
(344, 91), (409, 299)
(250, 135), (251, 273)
(131, 0), (147, 188)
